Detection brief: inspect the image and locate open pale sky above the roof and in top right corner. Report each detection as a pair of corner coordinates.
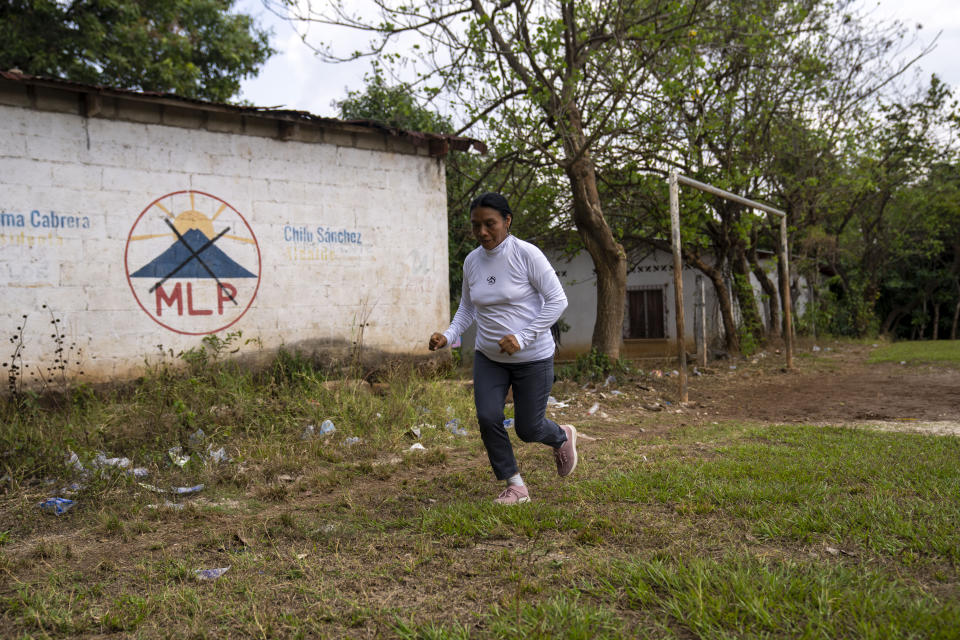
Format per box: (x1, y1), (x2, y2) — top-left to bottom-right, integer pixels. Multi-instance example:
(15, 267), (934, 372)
(236, 0), (960, 117)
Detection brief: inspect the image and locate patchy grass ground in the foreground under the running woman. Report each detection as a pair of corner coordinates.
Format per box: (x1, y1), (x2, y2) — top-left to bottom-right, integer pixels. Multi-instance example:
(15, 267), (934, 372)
(0, 352), (960, 638)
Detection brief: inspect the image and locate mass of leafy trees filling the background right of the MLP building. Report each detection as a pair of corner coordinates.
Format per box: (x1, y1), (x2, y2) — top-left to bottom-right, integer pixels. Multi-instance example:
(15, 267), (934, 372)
(308, 0), (960, 350)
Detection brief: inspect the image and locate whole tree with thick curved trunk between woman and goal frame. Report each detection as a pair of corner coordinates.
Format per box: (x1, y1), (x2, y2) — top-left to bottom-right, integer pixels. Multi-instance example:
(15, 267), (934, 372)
(277, 0), (703, 359)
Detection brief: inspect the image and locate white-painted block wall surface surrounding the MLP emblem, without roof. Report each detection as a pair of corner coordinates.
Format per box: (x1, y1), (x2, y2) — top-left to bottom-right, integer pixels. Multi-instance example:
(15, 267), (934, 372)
(0, 106), (449, 381)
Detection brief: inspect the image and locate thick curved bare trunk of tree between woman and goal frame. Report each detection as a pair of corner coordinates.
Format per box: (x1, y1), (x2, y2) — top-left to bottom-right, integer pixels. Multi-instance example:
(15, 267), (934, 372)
(566, 149), (627, 360)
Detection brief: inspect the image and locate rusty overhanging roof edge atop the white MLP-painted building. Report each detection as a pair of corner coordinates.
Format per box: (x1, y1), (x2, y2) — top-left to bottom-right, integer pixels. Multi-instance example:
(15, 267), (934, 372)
(0, 69), (487, 156)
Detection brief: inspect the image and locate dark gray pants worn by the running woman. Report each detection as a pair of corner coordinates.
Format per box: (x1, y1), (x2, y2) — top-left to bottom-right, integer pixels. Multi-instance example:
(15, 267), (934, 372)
(473, 351), (567, 480)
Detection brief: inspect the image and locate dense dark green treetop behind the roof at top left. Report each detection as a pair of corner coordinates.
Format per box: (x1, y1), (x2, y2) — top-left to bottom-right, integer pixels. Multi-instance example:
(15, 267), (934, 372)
(0, 0), (273, 102)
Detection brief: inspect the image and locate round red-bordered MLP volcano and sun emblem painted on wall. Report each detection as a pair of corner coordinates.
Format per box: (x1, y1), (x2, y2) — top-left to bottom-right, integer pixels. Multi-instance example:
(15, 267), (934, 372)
(125, 191), (260, 335)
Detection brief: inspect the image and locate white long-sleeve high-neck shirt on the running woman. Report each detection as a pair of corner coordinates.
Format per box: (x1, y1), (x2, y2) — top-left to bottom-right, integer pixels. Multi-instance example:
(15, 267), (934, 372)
(443, 235), (567, 362)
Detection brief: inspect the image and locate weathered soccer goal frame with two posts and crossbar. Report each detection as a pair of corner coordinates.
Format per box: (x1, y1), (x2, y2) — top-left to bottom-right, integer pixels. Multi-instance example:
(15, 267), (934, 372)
(668, 171), (793, 402)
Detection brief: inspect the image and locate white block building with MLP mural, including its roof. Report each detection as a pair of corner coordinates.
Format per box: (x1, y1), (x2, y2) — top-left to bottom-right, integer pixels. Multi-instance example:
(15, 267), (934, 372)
(0, 72), (482, 381)
